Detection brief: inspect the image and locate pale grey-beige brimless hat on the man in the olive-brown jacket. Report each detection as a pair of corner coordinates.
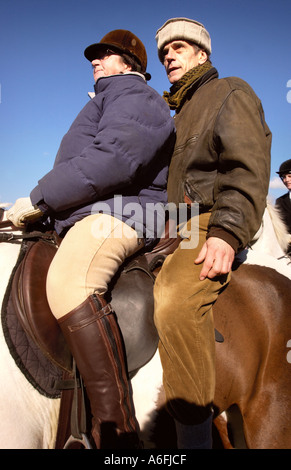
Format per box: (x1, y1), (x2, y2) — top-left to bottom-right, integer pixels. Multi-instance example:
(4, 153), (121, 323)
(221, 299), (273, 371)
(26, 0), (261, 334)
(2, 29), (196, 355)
(156, 18), (211, 62)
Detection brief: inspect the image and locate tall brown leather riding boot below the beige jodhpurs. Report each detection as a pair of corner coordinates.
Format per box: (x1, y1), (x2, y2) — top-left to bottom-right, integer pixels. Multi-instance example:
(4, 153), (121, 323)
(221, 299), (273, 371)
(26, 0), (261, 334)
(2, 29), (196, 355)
(59, 294), (140, 449)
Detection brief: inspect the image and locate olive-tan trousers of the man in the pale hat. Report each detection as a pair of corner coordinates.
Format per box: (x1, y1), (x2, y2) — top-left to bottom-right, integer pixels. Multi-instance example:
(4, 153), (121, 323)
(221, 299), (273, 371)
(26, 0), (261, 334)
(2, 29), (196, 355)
(155, 213), (230, 424)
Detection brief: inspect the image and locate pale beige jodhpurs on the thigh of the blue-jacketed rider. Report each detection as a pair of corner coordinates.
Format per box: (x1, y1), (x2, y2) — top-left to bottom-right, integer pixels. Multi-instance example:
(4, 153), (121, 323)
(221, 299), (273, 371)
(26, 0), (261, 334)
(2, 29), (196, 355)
(47, 214), (143, 319)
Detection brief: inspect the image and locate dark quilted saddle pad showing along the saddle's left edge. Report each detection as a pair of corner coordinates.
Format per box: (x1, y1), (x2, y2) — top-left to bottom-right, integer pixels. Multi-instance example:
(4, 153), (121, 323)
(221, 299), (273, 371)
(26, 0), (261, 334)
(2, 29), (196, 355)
(1, 241), (63, 398)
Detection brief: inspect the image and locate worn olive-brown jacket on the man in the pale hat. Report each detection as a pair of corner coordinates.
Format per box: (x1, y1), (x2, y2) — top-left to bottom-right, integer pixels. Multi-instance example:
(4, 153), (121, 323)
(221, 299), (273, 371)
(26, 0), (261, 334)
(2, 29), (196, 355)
(168, 68), (271, 252)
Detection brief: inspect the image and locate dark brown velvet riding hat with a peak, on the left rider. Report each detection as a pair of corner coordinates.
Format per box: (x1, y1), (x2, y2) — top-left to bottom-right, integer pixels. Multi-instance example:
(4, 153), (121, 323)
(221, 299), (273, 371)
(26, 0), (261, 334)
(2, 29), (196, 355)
(84, 29), (147, 73)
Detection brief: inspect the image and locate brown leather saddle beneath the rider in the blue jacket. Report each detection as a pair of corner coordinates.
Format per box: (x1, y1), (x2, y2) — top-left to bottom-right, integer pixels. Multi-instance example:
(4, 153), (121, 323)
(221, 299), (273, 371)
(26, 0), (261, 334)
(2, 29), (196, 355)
(11, 229), (179, 373)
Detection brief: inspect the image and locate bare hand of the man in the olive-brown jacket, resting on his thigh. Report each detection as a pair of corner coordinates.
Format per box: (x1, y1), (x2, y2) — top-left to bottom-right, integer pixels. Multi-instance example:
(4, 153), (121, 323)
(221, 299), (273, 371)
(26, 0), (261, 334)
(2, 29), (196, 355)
(195, 237), (235, 280)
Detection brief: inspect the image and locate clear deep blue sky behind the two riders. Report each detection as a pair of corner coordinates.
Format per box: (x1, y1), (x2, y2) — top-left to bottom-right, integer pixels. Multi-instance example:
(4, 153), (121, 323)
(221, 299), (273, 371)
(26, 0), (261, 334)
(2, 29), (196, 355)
(0, 0), (291, 203)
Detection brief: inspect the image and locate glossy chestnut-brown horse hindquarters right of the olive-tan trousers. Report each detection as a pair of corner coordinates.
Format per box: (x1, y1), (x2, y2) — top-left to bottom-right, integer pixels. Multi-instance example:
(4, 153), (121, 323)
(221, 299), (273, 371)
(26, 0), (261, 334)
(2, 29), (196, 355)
(214, 265), (291, 449)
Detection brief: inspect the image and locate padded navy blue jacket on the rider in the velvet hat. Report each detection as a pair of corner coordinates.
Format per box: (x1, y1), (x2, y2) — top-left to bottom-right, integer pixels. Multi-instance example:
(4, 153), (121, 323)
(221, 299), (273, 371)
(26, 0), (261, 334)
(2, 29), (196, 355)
(30, 73), (175, 245)
